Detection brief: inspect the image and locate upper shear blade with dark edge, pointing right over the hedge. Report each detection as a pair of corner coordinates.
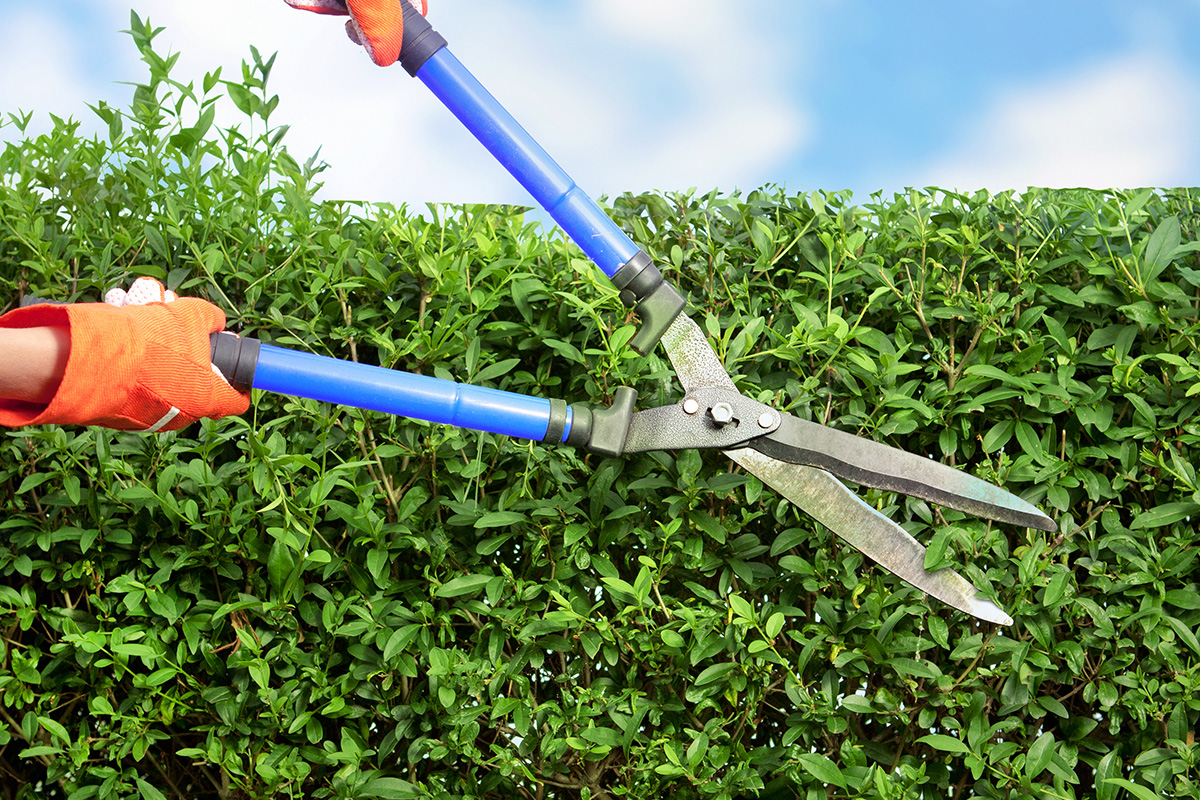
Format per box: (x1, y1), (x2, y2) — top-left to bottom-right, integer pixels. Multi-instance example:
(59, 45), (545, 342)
(750, 414), (1057, 531)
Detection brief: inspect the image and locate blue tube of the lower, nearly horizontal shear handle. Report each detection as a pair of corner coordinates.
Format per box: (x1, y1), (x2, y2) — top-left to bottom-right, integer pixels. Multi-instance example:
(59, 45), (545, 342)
(252, 344), (571, 441)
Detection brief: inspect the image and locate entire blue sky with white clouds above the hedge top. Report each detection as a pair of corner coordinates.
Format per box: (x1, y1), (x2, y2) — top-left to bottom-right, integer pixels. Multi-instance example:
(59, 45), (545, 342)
(0, 0), (1200, 205)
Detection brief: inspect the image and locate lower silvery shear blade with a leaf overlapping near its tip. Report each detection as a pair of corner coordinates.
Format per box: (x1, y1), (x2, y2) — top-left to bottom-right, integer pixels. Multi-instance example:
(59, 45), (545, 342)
(725, 447), (1013, 625)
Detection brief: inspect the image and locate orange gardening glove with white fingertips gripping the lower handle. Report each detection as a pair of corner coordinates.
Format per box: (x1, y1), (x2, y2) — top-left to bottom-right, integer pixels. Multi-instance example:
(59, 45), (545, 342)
(0, 278), (250, 433)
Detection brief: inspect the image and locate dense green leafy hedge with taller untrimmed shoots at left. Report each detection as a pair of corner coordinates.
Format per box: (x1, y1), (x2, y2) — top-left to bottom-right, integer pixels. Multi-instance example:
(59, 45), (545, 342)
(0, 19), (1200, 800)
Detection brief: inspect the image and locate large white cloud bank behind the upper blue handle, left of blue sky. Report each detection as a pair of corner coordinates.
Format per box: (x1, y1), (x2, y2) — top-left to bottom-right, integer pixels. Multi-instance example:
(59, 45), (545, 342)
(0, 0), (808, 208)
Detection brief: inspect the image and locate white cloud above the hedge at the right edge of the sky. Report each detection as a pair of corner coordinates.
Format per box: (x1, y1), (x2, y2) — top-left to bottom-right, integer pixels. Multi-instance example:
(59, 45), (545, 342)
(912, 53), (1200, 190)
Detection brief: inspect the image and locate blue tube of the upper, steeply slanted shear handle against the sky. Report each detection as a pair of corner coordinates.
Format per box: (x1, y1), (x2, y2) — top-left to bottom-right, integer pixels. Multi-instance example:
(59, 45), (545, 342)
(416, 47), (638, 278)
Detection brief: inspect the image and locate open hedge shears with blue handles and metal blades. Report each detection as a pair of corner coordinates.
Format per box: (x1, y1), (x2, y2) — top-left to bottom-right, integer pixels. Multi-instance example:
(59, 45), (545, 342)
(212, 9), (1056, 625)
